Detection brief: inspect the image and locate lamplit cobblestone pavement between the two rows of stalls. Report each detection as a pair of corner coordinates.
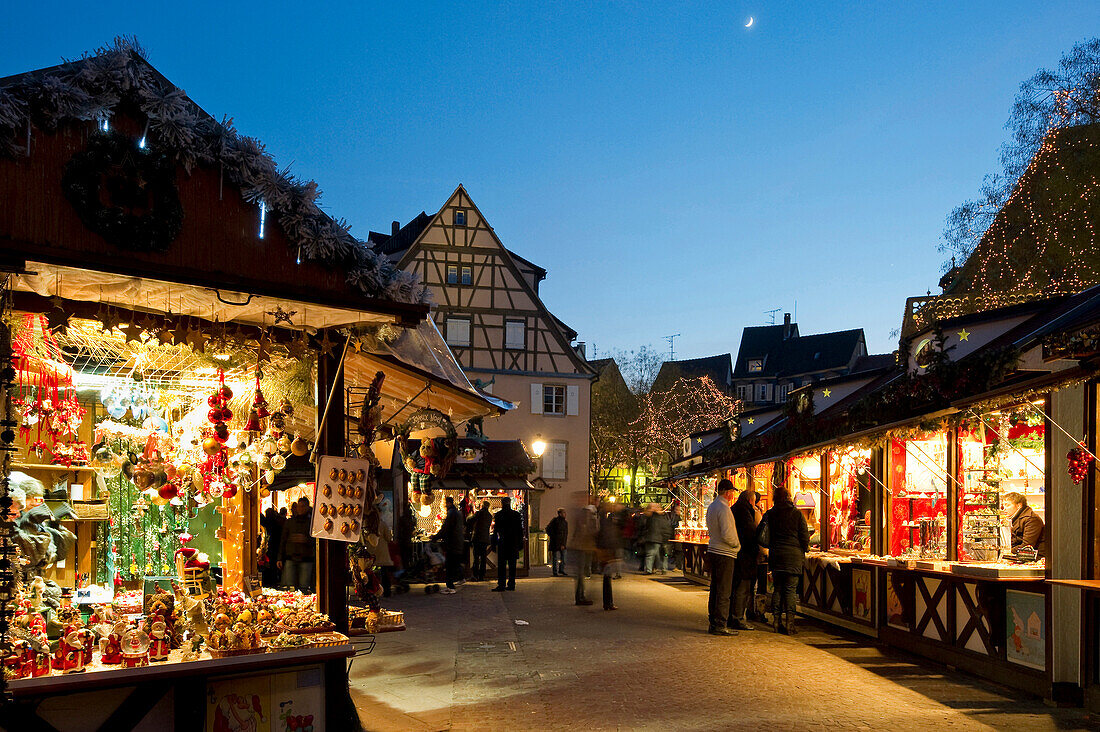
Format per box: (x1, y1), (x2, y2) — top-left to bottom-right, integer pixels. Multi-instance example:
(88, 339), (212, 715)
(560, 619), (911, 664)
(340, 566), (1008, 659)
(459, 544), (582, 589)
(351, 569), (1095, 732)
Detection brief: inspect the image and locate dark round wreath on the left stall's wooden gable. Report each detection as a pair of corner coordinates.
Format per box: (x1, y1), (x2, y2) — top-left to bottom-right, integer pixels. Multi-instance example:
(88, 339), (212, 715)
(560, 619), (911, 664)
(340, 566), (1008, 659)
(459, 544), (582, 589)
(62, 132), (184, 252)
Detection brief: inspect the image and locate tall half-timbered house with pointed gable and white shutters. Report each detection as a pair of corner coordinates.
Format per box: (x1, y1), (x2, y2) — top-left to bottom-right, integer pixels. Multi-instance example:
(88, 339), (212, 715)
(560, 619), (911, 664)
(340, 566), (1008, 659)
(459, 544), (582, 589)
(369, 185), (595, 527)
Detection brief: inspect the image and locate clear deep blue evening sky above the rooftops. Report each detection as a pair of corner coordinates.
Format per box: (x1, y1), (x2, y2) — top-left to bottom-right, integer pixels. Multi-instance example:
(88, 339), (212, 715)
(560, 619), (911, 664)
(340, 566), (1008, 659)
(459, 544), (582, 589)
(0, 0), (1100, 358)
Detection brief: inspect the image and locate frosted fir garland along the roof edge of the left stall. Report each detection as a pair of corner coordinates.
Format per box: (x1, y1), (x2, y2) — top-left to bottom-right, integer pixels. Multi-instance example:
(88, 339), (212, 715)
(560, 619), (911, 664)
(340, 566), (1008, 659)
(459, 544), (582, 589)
(0, 37), (429, 303)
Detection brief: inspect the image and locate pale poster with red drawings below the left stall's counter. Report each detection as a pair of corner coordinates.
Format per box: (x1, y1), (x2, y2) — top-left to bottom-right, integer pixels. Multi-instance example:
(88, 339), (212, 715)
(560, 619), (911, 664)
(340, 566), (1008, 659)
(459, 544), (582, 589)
(206, 666), (325, 732)
